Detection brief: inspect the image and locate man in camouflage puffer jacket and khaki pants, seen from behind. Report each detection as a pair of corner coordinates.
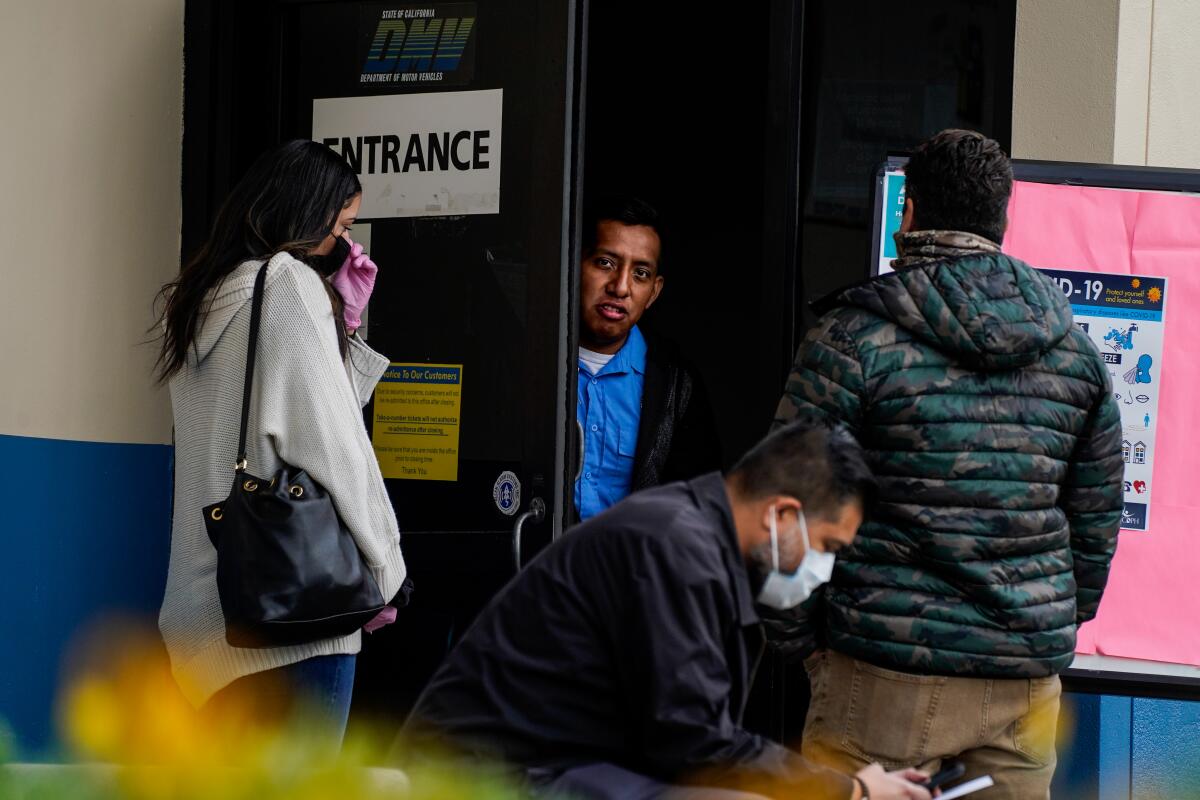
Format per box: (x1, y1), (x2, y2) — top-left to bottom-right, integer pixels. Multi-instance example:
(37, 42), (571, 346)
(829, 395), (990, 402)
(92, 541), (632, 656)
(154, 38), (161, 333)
(775, 131), (1123, 800)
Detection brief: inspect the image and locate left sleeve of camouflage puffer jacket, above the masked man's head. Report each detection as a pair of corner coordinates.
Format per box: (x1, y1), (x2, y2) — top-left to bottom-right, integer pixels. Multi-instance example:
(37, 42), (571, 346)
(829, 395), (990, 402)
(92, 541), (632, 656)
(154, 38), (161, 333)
(772, 312), (864, 433)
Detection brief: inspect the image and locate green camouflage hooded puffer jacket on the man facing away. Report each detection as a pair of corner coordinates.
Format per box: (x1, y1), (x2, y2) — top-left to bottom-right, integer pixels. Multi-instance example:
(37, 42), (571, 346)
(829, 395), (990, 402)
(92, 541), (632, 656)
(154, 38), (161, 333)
(775, 242), (1123, 678)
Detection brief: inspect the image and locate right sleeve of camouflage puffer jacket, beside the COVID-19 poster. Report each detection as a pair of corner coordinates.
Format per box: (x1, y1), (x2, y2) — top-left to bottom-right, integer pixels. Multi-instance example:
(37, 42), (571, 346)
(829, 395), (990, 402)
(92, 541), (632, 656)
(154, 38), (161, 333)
(1058, 369), (1124, 625)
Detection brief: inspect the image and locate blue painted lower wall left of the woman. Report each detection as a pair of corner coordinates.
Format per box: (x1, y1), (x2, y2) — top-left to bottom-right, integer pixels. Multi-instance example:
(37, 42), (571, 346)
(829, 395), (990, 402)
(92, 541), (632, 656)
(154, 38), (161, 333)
(0, 435), (172, 756)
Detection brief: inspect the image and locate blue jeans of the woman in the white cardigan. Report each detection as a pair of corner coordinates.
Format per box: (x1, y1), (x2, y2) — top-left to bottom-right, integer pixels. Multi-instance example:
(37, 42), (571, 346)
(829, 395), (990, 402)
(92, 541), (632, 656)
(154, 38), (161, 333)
(200, 655), (358, 748)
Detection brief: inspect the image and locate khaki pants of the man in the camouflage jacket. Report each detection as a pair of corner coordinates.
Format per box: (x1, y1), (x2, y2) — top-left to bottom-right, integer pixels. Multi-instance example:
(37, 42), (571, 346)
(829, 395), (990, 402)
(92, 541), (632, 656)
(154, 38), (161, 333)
(803, 650), (1062, 800)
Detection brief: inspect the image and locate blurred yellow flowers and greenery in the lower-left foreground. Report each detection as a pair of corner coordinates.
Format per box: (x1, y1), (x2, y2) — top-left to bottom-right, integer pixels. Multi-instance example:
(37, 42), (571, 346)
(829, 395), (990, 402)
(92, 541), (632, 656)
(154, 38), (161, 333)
(48, 625), (530, 800)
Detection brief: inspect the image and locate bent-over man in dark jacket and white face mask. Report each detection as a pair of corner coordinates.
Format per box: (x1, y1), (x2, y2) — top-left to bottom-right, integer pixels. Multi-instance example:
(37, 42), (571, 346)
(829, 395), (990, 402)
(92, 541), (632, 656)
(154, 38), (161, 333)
(412, 422), (930, 800)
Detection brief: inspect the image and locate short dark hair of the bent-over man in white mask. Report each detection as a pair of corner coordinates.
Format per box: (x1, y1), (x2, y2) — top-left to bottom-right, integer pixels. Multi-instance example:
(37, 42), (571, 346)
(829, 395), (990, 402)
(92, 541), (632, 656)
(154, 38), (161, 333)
(730, 419), (876, 519)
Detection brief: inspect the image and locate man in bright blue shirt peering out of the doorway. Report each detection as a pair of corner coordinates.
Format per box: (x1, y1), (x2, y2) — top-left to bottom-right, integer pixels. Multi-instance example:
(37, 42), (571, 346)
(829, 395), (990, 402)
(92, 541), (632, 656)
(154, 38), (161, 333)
(575, 197), (721, 519)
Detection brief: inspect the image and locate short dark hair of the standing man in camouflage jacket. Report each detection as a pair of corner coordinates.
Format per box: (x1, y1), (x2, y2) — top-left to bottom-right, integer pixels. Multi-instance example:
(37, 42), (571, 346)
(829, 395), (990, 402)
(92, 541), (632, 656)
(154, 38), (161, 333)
(904, 130), (1013, 245)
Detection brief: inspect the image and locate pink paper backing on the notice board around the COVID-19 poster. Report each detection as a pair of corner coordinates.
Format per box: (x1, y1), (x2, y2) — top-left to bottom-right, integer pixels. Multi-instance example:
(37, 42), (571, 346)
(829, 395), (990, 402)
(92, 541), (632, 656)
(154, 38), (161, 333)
(1004, 182), (1200, 666)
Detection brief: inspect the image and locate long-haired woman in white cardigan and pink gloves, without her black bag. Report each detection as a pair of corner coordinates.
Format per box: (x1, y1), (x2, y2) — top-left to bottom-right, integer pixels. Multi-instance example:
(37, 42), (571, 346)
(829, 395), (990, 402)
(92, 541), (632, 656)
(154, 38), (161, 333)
(158, 140), (406, 740)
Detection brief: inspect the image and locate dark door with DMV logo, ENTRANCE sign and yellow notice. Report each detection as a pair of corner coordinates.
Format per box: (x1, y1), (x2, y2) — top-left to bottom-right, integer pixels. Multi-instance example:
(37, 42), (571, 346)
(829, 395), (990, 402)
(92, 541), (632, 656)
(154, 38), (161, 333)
(185, 0), (582, 717)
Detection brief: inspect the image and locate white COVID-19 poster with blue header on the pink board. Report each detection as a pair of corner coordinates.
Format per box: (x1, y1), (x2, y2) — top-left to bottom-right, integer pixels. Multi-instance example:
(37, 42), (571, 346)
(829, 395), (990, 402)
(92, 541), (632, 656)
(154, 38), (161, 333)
(1042, 270), (1166, 530)
